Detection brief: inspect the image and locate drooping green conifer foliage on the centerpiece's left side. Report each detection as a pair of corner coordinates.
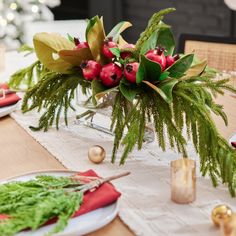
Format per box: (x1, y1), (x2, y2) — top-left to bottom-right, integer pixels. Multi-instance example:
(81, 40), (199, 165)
(22, 72), (90, 131)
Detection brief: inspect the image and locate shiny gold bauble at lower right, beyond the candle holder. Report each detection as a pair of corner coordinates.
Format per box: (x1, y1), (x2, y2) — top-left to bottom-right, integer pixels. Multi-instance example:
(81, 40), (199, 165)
(211, 205), (233, 226)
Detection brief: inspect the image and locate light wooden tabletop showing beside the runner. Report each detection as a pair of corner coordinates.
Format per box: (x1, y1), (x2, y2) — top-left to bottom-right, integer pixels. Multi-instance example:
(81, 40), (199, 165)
(0, 78), (236, 236)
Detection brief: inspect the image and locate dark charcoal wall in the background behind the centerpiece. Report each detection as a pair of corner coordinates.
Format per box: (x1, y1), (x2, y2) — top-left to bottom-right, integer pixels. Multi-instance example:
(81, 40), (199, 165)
(53, 0), (236, 45)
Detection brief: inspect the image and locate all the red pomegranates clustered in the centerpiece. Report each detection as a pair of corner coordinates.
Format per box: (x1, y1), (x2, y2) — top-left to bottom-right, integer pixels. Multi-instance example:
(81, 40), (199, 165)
(75, 38), (179, 88)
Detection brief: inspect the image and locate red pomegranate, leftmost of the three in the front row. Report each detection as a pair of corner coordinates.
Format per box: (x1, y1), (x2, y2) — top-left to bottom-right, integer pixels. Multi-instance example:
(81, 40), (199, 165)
(80, 60), (102, 80)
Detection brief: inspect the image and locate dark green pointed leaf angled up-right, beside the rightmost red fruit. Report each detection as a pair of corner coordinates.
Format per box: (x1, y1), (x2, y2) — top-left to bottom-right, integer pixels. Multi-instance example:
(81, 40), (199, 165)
(167, 54), (194, 79)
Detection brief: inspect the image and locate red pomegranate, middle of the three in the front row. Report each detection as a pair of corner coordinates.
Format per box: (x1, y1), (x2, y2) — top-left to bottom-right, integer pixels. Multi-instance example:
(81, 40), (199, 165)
(100, 63), (122, 87)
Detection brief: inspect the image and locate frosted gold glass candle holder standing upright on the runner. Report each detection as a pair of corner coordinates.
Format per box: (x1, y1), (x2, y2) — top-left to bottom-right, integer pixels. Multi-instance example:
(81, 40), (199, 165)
(171, 158), (196, 204)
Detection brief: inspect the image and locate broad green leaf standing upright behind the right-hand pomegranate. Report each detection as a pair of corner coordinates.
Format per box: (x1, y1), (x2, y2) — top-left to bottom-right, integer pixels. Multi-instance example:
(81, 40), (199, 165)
(140, 23), (175, 55)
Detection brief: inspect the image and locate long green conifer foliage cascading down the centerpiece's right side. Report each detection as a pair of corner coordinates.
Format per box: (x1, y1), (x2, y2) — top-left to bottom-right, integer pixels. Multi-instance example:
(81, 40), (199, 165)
(112, 77), (236, 196)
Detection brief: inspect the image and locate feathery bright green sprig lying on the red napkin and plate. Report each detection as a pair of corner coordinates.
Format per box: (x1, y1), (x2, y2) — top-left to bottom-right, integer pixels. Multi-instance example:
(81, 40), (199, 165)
(0, 176), (83, 236)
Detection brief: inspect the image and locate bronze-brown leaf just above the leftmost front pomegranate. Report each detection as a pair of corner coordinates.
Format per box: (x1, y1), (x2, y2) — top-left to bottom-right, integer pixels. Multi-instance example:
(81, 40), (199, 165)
(58, 48), (93, 66)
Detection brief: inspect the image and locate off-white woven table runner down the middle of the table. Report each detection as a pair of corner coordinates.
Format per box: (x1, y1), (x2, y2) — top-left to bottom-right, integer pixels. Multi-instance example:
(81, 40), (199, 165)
(0, 51), (236, 236)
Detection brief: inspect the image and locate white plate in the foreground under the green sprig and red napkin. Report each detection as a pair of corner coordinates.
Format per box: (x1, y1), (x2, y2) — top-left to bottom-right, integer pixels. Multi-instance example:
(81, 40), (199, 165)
(0, 171), (118, 236)
